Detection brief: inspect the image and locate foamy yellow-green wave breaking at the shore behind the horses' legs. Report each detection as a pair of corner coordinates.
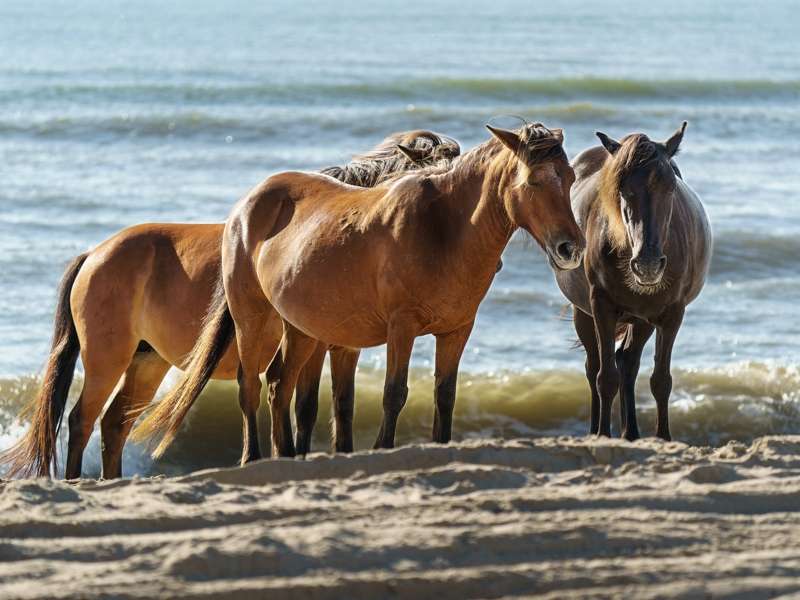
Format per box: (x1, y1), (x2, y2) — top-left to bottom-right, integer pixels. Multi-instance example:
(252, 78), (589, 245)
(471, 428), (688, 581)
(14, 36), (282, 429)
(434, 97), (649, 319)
(0, 362), (800, 475)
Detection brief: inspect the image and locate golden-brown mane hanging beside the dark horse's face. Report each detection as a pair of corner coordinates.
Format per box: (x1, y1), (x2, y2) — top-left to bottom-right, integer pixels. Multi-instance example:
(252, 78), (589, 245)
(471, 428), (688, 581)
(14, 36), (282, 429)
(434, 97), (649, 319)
(600, 133), (659, 250)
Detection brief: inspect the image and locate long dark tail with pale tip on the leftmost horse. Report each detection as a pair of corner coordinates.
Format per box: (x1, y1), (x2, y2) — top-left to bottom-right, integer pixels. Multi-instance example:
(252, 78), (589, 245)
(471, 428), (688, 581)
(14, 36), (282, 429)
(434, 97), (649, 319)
(0, 252), (89, 477)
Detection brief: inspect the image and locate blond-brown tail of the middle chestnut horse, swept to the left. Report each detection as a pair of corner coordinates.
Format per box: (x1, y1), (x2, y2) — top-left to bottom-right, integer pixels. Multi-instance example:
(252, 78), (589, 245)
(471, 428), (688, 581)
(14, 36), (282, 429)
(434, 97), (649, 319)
(131, 281), (235, 458)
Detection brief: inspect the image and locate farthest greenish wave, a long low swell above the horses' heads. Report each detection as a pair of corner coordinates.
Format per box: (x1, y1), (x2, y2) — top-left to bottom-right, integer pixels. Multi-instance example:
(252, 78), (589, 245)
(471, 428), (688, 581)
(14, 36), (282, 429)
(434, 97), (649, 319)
(6, 77), (800, 104)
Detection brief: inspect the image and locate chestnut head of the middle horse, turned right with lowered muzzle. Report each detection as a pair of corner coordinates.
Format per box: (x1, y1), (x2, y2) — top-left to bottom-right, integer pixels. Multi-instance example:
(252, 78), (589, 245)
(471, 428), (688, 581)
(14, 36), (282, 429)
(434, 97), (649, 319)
(487, 123), (586, 270)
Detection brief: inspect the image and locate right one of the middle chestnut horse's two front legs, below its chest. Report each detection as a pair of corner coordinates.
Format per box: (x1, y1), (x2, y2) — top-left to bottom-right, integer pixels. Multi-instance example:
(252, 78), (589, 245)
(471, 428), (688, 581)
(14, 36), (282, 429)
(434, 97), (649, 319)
(433, 321), (475, 444)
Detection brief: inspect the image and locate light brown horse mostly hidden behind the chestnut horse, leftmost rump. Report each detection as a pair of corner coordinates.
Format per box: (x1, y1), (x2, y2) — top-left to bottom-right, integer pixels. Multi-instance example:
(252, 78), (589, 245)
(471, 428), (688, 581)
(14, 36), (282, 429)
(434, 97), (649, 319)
(0, 130), (460, 479)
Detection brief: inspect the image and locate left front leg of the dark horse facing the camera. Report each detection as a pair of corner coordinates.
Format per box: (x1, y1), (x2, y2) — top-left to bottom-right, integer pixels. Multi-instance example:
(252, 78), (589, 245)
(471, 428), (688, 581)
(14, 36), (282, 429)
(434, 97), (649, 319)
(591, 288), (619, 437)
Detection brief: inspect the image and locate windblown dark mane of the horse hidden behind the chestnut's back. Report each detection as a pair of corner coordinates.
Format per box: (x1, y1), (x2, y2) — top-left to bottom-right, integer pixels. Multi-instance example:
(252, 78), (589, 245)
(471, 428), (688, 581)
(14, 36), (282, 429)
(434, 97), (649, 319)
(321, 129), (461, 187)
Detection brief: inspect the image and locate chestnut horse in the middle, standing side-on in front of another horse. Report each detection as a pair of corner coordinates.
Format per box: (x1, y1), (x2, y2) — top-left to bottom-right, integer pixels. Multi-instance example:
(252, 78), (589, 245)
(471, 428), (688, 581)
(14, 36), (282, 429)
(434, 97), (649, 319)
(136, 124), (584, 456)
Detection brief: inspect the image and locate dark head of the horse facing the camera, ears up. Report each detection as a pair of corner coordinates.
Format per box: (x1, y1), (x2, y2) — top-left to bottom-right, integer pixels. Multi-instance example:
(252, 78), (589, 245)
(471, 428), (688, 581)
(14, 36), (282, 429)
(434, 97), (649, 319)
(597, 121), (686, 289)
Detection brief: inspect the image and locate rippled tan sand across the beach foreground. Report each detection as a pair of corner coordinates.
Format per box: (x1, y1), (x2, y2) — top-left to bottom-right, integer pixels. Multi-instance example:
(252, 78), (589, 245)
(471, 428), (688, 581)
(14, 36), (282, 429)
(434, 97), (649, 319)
(0, 436), (800, 600)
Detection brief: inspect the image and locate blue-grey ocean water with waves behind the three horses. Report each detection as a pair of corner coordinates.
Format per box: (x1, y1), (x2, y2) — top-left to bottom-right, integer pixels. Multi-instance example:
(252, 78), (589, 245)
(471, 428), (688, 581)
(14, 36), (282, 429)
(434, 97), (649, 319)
(0, 0), (800, 474)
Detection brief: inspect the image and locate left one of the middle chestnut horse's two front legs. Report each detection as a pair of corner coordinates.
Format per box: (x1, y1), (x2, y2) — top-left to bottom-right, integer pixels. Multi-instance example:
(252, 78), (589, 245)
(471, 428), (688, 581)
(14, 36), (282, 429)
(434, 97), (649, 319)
(375, 318), (417, 448)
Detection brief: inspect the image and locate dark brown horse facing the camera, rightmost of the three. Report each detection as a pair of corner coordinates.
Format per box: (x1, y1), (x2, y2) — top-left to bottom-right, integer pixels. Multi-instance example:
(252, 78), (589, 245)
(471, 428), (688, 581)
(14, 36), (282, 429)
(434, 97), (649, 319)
(556, 122), (711, 440)
